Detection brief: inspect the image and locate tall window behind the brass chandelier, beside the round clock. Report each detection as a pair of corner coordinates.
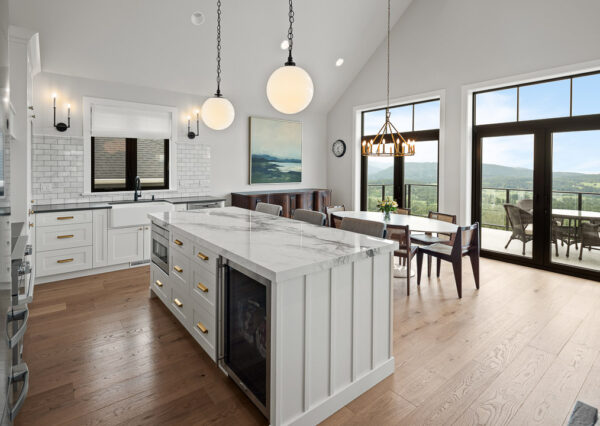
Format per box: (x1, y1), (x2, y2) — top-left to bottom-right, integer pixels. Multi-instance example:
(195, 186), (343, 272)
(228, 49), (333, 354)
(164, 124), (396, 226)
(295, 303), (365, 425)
(361, 99), (440, 216)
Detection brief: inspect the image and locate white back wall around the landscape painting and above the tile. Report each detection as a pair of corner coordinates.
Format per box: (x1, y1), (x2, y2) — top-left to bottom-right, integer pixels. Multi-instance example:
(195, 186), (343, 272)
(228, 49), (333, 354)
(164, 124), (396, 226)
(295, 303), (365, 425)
(34, 71), (327, 201)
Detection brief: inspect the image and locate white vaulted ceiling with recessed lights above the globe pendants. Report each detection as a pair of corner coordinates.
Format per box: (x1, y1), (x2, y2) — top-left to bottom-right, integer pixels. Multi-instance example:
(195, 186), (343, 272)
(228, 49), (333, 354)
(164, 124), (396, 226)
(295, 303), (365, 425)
(10, 0), (411, 111)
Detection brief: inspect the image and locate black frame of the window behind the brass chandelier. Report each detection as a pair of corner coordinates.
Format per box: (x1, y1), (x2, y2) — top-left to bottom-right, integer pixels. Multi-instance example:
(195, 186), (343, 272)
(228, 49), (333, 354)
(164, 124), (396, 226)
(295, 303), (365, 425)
(360, 98), (442, 214)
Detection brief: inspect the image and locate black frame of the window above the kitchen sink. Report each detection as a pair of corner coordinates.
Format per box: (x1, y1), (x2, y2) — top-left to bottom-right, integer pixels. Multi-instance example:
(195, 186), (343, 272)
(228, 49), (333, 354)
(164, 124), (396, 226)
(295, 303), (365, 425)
(90, 136), (170, 192)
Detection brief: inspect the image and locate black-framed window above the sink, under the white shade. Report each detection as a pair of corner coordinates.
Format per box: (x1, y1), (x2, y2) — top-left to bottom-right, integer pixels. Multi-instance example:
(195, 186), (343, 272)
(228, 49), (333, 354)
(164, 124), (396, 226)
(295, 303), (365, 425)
(92, 137), (169, 192)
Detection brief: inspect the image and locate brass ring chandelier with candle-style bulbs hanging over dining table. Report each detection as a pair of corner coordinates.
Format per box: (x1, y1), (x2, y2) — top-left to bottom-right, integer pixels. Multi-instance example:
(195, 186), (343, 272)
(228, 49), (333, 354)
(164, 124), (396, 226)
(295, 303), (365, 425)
(361, 0), (415, 157)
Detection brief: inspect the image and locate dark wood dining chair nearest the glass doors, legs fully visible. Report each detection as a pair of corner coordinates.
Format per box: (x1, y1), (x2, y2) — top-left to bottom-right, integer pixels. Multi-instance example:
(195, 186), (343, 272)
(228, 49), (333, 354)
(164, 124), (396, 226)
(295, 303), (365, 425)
(417, 223), (479, 299)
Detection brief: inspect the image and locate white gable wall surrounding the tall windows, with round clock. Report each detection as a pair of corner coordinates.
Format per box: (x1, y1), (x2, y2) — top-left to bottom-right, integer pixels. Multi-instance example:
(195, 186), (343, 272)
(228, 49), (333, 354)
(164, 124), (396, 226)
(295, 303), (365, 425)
(327, 0), (600, 222)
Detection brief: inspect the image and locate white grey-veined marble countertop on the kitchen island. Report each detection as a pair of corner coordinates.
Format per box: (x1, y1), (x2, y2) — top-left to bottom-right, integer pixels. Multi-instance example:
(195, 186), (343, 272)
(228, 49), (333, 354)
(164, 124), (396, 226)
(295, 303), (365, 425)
(148, 207), (397, 282)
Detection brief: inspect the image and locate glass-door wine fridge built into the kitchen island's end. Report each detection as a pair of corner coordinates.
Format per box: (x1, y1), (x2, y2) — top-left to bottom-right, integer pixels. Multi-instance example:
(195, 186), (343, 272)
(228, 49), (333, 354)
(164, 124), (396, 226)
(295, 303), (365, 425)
(219, 260), (271, 419)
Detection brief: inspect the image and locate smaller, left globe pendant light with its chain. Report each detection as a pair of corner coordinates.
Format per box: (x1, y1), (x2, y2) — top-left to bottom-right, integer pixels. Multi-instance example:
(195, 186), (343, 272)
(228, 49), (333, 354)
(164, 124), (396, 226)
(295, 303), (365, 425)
(202, 0), (235, 130)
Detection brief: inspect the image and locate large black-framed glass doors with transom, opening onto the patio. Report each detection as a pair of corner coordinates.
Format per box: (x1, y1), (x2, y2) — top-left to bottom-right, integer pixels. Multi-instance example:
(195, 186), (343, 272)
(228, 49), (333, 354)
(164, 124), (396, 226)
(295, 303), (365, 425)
(473, 73), (600, 279)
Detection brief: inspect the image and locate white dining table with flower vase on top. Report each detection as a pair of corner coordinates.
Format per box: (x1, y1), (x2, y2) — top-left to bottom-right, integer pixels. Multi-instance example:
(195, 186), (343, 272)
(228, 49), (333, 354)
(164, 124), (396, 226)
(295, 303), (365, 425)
(330, 210), (458, 278)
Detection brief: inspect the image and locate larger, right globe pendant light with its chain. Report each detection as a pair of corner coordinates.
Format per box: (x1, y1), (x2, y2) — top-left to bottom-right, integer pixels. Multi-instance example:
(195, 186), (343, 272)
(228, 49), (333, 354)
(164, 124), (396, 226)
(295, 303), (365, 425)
(267, 0), (315, 114)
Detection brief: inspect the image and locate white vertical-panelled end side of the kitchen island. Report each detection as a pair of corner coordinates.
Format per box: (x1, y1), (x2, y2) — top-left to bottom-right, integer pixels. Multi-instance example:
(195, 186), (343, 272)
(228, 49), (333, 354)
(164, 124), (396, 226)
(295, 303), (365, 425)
(270, 253), (393, 424)
